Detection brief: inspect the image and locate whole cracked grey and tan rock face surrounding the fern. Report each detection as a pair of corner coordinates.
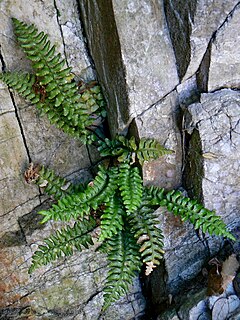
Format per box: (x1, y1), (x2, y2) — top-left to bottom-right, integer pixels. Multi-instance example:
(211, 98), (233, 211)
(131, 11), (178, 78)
(0, 0), (240, 320)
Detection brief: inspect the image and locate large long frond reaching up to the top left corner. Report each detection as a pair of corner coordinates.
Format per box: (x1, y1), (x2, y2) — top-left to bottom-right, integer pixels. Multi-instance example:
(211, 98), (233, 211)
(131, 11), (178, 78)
(13, 19), (102, 143)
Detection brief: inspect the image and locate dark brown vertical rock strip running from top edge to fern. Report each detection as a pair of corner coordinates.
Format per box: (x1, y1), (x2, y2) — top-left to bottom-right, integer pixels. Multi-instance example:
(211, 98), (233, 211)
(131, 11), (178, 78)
(78, 0), (130, 136)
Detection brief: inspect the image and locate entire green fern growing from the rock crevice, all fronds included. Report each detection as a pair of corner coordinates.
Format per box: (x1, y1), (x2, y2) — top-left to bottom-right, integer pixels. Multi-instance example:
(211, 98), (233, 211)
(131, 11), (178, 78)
(0, 19), (234, 310)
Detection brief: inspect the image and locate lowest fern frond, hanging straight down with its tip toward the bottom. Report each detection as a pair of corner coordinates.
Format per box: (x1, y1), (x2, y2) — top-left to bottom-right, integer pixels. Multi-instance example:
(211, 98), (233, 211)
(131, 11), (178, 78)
(103, 228), (142, 310)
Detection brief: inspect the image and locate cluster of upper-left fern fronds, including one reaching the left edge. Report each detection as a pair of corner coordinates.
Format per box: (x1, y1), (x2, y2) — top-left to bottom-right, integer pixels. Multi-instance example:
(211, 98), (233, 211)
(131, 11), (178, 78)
(0, 19), (106, 143)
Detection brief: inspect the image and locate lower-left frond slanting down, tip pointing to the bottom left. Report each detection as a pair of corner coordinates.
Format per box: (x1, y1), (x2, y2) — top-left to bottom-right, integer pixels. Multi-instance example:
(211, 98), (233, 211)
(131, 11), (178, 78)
(29, 217), (96, 273)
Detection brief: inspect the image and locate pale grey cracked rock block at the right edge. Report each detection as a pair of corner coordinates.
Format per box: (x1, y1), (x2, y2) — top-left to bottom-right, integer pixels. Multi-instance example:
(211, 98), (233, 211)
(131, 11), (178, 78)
(188, 89), (240, 224)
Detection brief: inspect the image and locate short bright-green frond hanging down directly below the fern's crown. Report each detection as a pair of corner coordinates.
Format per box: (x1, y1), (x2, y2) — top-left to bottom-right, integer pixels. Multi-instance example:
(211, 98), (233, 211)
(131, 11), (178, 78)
(118, 163), (143, 214)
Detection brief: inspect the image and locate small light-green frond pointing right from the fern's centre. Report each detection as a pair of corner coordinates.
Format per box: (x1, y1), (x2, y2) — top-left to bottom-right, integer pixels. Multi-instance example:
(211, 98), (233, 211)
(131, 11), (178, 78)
(136, 138), (173, 165)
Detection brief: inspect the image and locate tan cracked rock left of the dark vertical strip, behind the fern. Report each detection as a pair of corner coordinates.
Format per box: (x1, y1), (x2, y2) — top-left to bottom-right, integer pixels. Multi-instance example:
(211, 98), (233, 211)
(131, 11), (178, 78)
(0, 0), (145, 320)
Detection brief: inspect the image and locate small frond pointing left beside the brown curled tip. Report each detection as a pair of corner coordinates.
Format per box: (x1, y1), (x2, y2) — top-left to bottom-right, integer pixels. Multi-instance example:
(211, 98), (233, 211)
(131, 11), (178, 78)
(36, 166), (85, 199)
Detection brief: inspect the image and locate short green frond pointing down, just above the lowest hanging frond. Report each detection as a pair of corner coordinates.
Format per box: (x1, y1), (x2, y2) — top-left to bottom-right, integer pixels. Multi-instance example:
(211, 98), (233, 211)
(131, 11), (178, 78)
(99, 194), (125, 241)
